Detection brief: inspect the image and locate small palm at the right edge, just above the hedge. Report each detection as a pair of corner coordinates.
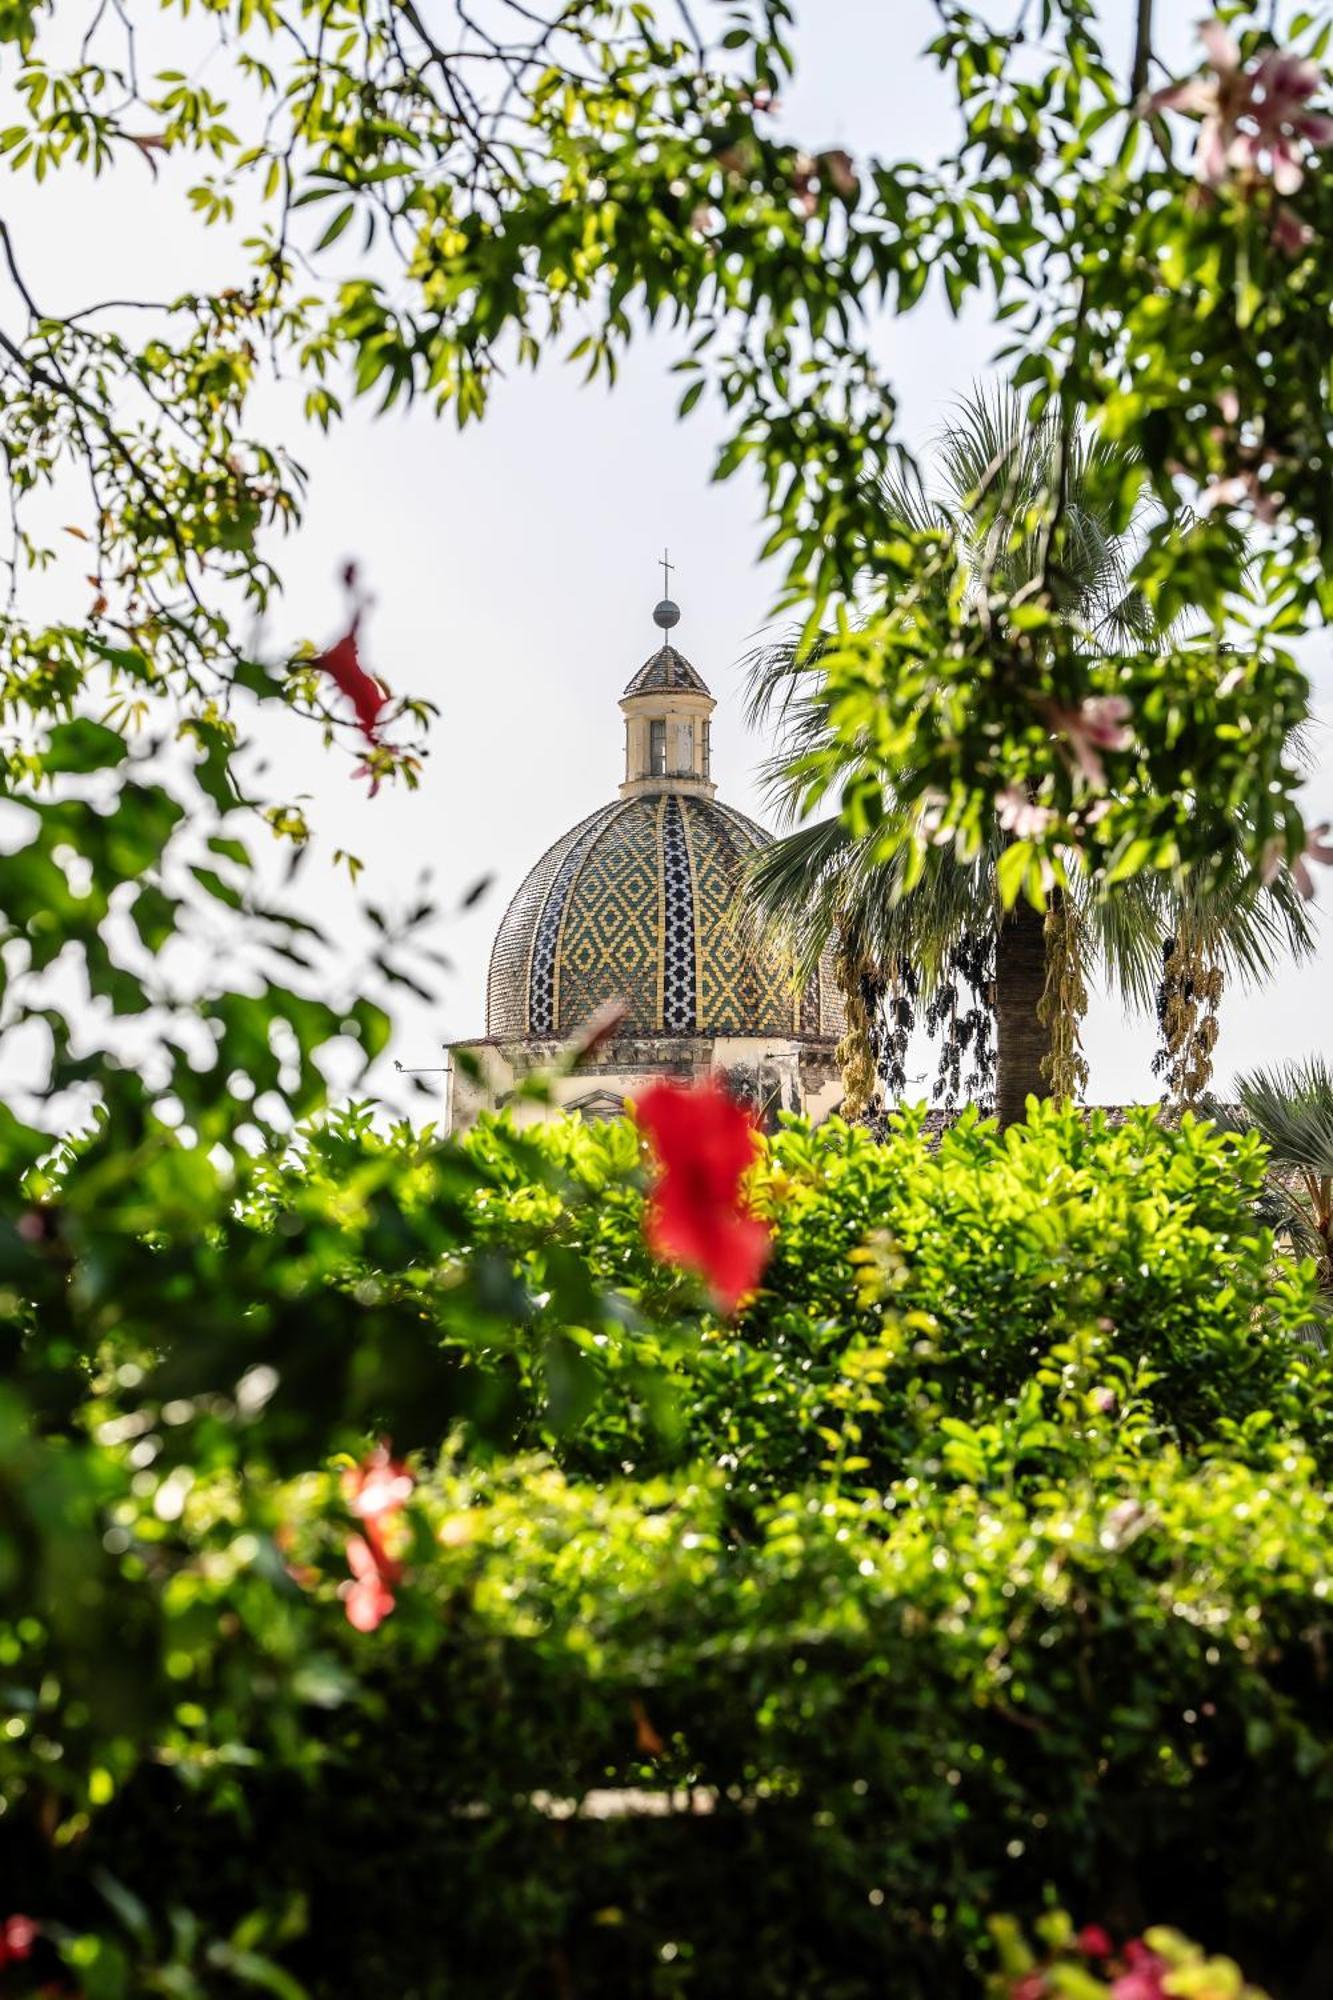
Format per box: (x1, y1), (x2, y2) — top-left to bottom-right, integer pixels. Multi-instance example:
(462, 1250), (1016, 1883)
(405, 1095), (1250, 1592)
(1209, 1056), (1333, 1314)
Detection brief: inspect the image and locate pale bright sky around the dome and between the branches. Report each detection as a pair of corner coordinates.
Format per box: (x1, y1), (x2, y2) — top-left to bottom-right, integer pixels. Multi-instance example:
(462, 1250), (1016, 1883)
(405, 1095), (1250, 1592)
(4, 0), (1333, 1102)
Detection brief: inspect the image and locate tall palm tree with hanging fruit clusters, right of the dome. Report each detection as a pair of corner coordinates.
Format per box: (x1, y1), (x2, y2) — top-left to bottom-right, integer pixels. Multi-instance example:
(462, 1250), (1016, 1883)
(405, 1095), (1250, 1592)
(749, 392), (1311, 1124)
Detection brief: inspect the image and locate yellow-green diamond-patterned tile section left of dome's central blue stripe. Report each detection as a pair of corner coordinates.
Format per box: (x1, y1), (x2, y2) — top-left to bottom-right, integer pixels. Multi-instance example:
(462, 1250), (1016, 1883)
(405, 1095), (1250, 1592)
(548, 796), (660, 1034)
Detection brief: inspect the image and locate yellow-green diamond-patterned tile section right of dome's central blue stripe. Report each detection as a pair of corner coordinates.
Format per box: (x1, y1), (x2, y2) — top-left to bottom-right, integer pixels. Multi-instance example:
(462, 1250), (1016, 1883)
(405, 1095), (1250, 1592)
(681, 798), (793, 1036)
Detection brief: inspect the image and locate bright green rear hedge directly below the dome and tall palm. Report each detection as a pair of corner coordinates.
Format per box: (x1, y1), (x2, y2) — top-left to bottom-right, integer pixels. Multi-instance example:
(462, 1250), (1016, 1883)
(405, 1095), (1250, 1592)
(468, 1106), (1333, 1500)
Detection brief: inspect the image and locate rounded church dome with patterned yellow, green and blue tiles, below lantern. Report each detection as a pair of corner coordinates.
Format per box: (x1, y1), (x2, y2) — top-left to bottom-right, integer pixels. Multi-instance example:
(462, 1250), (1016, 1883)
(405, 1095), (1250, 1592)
(486, 792), (843, 1040)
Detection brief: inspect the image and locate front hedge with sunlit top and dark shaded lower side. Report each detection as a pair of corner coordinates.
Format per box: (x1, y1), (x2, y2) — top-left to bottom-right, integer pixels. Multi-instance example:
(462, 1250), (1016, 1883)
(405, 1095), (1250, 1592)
(46, 1452), (1333, 2000)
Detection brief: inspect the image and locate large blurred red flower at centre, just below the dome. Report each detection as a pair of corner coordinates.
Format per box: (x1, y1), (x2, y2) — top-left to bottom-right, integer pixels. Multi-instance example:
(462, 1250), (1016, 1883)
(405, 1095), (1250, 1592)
(634, 1078), (771, 1312)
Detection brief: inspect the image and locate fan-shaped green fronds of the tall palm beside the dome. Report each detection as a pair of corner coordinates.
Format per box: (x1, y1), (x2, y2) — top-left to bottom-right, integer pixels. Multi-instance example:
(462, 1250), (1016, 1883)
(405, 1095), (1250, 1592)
(728, 386), (1313, 1088)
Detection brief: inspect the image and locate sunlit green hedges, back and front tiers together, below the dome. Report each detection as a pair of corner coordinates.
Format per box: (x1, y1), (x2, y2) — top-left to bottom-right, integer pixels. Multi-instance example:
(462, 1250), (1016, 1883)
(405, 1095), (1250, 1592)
(0, 1110), (1333, 2000)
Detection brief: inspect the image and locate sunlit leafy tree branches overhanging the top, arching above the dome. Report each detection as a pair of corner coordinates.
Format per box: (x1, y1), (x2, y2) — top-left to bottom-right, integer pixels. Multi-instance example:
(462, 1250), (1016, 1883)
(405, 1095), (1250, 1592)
(0, 0), (1333, 920)
